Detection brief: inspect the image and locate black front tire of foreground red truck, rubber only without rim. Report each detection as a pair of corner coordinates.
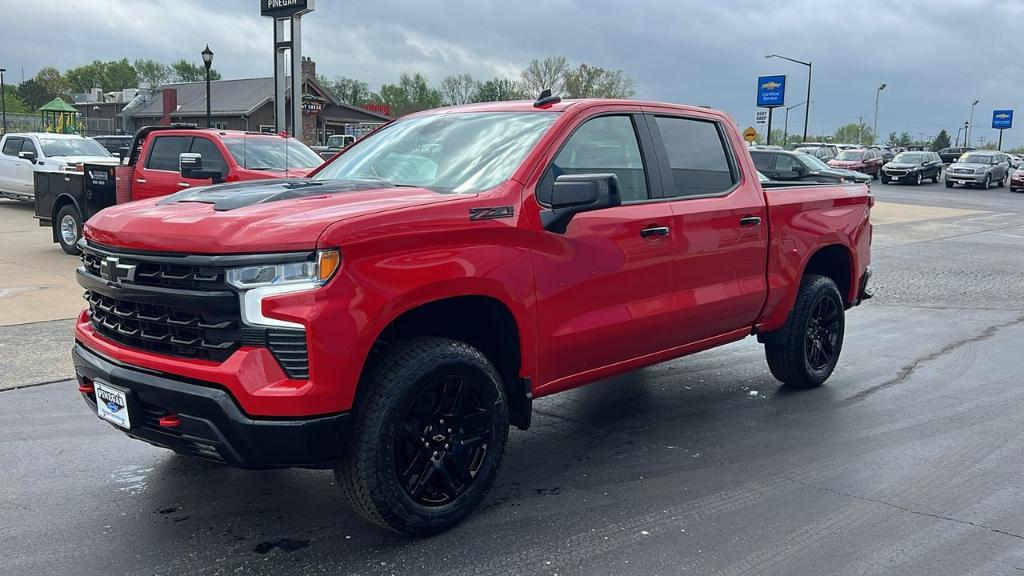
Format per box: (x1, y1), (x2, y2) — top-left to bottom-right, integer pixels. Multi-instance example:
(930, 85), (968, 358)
(335, 337), (509, 536)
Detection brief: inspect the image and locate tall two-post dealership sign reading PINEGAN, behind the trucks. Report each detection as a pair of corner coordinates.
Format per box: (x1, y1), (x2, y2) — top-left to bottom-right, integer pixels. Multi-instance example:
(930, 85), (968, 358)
(259, 0), (315, 138)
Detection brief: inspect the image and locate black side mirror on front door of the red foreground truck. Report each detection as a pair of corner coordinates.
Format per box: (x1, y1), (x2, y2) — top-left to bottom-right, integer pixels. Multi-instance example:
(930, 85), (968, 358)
(541, 174), (623, 234)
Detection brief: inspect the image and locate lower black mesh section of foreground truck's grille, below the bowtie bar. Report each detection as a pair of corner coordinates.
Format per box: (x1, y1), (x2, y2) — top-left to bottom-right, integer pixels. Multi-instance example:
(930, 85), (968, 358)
(86, 291), (240, 362)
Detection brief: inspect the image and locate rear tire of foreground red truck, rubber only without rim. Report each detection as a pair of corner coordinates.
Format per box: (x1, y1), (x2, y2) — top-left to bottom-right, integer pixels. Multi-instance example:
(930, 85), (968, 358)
(765, 275), (846, 388)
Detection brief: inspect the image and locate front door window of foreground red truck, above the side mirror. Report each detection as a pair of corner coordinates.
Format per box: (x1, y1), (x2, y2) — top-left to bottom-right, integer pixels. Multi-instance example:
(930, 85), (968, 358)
(538, 116), (649, 203)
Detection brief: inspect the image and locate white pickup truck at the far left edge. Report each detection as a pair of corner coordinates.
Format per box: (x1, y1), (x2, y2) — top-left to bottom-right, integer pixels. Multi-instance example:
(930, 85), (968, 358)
(0, 132), (118, 201)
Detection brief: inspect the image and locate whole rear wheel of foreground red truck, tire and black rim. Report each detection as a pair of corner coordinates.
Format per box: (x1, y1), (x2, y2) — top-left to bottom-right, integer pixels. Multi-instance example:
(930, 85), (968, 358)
(765, 275), (846, 388)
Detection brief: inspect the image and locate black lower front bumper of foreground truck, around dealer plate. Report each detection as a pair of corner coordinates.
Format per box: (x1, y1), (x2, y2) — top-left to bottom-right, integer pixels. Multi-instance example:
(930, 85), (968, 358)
(72, 343), (349, 468)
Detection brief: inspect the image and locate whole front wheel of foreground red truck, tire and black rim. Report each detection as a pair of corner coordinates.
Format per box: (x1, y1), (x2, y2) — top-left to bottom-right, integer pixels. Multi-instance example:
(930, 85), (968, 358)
(335, 338), (509, 536)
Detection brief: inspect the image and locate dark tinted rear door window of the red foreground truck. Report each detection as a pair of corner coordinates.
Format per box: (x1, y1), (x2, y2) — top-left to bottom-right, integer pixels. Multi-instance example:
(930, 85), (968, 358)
(655, 116), (737, 197)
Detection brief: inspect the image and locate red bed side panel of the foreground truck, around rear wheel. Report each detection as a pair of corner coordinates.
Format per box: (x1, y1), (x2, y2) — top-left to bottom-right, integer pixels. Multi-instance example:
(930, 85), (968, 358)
(757, 184), (871, 332)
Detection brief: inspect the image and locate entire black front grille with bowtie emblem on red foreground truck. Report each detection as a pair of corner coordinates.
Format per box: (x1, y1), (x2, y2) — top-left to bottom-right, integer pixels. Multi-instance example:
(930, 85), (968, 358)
(82, 241), (309, 379)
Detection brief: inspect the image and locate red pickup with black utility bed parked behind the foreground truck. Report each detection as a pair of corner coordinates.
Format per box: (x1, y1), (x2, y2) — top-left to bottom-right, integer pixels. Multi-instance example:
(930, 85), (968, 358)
(36, 124), (324, 254)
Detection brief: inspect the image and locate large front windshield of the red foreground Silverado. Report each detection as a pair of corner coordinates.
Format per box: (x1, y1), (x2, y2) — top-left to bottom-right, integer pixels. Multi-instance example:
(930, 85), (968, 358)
(315, 112), (557, 193)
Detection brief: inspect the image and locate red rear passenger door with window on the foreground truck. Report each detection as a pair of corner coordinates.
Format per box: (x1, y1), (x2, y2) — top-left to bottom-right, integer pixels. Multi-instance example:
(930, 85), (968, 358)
(646, 110), (765, 343)
